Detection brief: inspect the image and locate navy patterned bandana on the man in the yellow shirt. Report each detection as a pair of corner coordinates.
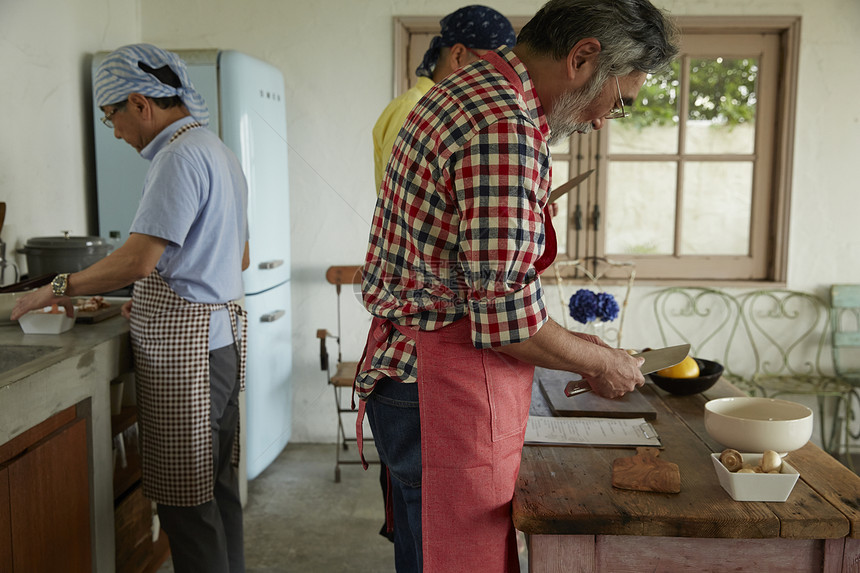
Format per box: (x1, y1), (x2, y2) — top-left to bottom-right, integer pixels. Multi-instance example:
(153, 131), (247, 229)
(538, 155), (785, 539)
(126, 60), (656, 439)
(415, 5), (517, 78)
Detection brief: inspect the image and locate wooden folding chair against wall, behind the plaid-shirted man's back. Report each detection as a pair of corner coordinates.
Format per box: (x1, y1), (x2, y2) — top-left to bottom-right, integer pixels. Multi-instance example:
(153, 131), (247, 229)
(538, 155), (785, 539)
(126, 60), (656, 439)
(317, 265), (373, 483)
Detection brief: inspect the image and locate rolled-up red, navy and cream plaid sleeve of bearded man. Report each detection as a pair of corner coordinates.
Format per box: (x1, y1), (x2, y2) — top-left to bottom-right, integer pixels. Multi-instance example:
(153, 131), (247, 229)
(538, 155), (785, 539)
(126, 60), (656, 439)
(450, 120), (550, 348)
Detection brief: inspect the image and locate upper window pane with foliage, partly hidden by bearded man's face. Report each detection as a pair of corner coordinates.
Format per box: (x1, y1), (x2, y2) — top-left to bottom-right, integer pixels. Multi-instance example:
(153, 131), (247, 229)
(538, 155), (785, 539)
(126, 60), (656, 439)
(609, 62), (680, 153)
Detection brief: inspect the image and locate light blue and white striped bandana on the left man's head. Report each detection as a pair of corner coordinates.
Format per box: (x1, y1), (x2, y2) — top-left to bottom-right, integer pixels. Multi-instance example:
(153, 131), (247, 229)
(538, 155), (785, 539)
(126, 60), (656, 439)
(93, 44), (209, 125)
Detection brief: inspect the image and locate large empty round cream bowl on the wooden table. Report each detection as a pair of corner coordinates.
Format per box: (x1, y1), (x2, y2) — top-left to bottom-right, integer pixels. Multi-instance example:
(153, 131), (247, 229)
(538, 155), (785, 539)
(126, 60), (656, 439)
(705, 396), (812, 453)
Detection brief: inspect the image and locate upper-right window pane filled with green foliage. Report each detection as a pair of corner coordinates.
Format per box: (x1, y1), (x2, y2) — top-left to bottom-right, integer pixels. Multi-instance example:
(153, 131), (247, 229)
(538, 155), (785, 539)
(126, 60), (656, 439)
(685, 58), (758, 153)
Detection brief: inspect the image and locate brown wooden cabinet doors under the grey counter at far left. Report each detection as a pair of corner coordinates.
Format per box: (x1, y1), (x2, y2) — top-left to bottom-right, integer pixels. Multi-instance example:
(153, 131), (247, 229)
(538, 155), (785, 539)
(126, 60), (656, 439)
(0, 406), (92, 573)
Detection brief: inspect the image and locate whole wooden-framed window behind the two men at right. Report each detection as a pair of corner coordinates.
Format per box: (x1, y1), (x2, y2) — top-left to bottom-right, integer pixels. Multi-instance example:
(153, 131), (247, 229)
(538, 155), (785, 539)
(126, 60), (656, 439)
(395, 17), (800, 283)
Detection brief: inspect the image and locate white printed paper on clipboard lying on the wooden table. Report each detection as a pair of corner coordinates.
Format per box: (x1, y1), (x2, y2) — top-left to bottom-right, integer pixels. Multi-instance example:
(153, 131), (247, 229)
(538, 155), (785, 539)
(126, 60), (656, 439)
(525, 416), (662, 447)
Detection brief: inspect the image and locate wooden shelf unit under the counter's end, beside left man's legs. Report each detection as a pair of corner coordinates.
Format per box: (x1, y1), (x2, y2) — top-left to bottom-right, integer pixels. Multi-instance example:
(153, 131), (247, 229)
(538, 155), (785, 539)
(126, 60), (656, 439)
(111, 407), (170, 573)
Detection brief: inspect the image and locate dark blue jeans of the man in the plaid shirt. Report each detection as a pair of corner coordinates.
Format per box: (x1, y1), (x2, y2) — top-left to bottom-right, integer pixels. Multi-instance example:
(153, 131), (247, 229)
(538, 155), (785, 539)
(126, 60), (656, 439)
(366, 378), (422, 573)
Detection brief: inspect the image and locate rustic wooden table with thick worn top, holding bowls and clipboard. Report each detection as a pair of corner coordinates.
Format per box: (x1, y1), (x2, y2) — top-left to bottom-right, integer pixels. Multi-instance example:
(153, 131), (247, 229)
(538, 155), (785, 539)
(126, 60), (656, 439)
(513, 380), (860, 573)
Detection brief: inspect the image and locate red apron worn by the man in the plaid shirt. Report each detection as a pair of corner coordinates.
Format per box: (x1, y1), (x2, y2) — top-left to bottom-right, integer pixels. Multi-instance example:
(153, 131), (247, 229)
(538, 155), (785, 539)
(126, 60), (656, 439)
(356, 214), (556, 573)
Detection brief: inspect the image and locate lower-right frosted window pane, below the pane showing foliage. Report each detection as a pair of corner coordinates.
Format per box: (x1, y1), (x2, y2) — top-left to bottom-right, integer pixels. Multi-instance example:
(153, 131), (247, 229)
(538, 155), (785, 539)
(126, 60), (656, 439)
(680, 162), (753, 255)
